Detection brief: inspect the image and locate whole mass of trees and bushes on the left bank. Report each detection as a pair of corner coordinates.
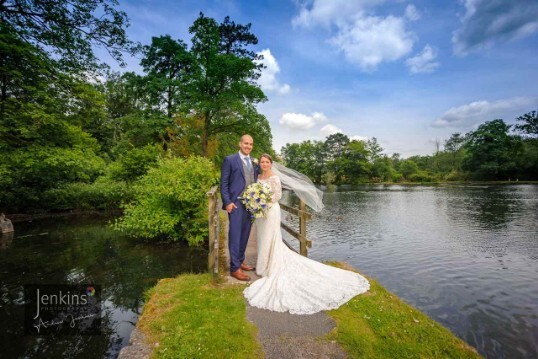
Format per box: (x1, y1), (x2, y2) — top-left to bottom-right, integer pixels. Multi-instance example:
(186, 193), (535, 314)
(0, 0), (272, 243)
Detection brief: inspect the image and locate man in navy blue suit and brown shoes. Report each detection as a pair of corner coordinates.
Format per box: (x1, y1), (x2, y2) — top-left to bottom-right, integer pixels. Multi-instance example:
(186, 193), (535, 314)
(220, 135), (258, 281)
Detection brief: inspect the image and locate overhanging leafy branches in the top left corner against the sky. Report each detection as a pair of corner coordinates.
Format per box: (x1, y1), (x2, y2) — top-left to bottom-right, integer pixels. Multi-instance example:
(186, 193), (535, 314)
(0, 0), (135, 73)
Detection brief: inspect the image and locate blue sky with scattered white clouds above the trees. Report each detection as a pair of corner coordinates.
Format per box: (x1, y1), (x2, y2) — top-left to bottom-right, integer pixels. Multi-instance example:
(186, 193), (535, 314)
(107, 0), (538, 157)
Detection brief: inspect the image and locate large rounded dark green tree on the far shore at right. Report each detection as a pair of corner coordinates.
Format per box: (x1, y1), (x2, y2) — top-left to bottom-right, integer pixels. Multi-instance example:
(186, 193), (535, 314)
(463, 119), (521, 180)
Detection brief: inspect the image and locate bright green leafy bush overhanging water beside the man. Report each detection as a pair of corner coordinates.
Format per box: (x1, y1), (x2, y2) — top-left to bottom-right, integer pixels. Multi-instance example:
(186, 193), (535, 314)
(114, 156), (218, 245)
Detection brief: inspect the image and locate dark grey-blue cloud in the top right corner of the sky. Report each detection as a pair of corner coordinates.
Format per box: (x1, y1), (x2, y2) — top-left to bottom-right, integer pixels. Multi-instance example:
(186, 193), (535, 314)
(452, 0), (538, 55)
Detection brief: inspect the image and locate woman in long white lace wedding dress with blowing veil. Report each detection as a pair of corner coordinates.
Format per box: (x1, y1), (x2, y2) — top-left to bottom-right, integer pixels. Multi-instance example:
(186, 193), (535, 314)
(243, 154), (370, 314)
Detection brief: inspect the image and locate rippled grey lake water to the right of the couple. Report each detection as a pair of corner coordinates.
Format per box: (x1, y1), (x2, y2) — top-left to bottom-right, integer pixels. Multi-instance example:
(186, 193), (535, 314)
(280, 185), (538, 358)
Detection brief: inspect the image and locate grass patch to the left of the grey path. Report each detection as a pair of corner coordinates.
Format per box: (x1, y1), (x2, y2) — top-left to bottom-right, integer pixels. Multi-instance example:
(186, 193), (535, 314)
(137, 274), (263, 358)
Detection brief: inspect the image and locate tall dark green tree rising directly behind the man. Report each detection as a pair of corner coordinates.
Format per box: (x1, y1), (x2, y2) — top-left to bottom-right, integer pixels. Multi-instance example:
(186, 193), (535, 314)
(184, 13), (266, 156)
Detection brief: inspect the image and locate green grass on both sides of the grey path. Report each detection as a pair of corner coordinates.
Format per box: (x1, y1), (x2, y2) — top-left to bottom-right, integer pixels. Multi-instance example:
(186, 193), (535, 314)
(137, 262), (480, 358)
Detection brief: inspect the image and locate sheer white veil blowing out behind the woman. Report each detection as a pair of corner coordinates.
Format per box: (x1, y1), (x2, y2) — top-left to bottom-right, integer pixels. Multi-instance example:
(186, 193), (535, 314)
(271, 162), (323, 212)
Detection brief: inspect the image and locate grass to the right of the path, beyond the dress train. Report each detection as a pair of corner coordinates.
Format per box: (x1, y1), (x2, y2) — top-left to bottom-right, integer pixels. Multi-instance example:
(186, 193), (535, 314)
(327, 262), (480, 358)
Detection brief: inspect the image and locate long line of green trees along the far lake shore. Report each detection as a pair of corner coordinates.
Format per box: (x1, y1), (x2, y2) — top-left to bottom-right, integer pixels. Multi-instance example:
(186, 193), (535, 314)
(281, 111), (538, 184)
